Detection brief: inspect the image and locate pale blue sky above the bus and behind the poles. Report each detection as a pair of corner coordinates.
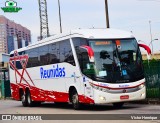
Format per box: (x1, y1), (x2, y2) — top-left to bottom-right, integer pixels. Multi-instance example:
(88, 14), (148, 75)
(0, 0), (160, 52)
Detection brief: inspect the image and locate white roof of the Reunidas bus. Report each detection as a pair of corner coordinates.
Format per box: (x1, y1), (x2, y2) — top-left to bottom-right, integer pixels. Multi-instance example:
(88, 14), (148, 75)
(11, 28), (134, 54)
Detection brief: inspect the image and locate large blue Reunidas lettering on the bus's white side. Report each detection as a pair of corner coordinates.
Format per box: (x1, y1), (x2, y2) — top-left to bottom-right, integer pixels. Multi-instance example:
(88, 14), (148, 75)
(40, 65), (66, 79)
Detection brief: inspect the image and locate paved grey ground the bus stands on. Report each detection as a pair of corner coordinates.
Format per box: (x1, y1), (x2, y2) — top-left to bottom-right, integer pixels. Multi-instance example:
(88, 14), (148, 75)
(0, 100), (160, 123)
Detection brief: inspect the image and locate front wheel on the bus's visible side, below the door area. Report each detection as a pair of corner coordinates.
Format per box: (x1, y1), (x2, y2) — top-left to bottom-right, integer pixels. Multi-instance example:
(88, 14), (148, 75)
(72, 90), (80, 110)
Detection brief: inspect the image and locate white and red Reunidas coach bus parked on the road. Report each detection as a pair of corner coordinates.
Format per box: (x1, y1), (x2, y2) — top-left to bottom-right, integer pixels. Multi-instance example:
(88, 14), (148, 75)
(9, 29), (146, 109)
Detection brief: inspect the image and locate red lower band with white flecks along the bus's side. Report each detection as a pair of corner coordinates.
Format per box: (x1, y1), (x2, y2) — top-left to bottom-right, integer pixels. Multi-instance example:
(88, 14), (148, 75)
(11, 83), (94, 104)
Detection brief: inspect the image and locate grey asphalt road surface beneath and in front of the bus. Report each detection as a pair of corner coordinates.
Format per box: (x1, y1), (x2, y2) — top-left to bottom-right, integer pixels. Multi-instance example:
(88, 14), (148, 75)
(0, 99), (160, 123)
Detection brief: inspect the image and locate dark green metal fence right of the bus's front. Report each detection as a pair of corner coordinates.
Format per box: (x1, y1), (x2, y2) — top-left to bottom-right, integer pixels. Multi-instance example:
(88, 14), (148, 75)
(143, 60), (160, 99)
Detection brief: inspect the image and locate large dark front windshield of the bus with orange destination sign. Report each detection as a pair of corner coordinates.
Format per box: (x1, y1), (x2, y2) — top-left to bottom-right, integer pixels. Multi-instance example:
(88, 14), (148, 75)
(73, 38), (144, 83)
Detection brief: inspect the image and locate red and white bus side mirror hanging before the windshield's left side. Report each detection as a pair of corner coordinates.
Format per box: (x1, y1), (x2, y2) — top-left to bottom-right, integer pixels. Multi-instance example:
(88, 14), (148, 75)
(79, 45), (94, 62)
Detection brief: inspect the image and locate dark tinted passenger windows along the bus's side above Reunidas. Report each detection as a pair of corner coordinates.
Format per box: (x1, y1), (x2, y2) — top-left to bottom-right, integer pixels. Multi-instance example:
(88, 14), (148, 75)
(10, 40), (75, 69)
